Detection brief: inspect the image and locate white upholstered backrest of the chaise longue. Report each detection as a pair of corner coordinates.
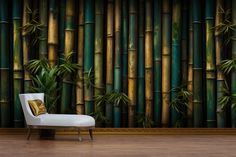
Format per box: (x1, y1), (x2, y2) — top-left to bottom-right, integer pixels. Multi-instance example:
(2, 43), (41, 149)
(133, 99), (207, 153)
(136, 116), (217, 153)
(19, 93), (44, 125)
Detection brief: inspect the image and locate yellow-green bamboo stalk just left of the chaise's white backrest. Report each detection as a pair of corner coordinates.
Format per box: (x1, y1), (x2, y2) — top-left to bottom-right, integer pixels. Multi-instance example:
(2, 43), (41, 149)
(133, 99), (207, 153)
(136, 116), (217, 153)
(12, 0), (24, 127)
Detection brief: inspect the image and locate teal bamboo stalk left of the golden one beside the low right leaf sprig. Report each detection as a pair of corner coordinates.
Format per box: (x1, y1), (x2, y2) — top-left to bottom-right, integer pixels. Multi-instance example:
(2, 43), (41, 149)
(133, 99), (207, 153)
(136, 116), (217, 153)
(153, 0), (162, 127)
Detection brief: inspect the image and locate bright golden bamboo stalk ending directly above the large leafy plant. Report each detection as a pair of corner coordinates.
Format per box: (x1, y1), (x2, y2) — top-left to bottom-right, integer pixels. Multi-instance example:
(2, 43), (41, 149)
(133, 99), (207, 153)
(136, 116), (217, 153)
(48, 0), (58, 65)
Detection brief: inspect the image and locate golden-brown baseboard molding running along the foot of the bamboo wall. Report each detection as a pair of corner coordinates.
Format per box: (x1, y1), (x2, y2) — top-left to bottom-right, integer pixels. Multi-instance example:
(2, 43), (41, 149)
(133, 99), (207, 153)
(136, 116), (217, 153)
(0, 128), (236, 135)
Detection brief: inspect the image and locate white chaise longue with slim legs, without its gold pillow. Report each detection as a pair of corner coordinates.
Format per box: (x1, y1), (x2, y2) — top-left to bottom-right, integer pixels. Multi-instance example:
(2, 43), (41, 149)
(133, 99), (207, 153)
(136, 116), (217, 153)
(19, 93), (95, 140)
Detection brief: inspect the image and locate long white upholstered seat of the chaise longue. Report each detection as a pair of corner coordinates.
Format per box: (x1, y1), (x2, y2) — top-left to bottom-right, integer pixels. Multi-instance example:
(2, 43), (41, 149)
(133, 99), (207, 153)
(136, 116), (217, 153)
(38, 114), (95, 127)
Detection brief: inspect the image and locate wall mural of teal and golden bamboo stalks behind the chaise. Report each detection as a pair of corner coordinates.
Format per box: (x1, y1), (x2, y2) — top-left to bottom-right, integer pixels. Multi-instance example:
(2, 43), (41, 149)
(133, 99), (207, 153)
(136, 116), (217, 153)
(0, 0), (236, 128)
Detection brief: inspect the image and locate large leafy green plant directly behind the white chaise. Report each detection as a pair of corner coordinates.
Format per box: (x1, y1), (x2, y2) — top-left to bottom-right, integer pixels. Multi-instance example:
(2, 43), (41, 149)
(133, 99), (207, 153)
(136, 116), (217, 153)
(25, 54), (78, 113)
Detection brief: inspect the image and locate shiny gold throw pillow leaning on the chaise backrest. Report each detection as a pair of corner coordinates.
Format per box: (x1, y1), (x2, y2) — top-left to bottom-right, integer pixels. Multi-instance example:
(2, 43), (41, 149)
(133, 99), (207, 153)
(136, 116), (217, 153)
(28, 99), (47, 116)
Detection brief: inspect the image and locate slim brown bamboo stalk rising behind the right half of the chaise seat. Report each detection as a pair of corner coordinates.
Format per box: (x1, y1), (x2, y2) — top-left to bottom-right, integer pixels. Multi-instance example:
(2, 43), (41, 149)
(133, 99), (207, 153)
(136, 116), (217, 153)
(76, 0), (84, 114)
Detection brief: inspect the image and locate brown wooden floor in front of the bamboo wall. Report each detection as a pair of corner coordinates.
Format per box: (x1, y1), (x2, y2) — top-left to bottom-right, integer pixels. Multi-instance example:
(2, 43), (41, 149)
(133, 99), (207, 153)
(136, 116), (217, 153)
(0, 134), (236, 157)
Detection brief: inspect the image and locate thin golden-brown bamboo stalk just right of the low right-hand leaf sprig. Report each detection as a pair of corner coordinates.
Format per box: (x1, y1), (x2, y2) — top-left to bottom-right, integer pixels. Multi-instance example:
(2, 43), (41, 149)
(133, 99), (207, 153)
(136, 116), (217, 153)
(187, 2), (193, 127)
